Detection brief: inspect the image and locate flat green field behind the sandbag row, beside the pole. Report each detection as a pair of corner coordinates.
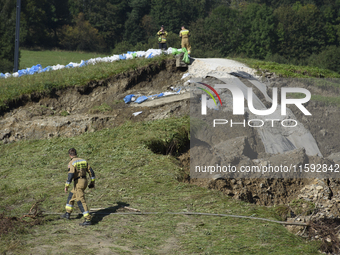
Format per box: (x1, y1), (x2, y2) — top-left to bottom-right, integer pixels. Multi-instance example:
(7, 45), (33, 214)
(19, 50), (108, 69)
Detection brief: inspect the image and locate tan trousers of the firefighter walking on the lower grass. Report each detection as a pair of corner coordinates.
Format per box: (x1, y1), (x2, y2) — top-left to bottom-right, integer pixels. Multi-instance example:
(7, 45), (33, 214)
(65, 178), (91, 220)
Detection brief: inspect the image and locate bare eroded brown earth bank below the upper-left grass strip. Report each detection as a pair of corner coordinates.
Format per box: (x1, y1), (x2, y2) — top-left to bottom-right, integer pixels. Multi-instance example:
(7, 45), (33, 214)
(0, 59), (188, 143)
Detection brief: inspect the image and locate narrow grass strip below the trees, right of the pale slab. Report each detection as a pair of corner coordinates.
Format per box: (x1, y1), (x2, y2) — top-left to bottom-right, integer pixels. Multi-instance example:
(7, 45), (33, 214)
(234, 58), (340, 78)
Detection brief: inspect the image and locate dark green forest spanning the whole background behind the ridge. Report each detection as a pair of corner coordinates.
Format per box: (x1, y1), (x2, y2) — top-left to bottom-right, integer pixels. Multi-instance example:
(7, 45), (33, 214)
(0, 0), (340, 70)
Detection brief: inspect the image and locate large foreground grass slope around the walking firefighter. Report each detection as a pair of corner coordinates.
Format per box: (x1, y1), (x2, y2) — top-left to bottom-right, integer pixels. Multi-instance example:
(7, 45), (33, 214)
(0, 117), (318, 254)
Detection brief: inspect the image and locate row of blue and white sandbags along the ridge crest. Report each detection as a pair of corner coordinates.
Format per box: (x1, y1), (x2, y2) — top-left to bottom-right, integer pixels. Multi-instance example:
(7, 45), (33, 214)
(0, 47), (186, 79)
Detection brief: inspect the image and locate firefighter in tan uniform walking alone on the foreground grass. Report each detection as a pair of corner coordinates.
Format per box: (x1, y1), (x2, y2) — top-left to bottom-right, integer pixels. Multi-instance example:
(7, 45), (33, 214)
(62, 148), (95, 226)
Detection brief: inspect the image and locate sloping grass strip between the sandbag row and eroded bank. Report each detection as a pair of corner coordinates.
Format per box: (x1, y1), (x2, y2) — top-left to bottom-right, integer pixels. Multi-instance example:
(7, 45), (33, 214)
(0, 55), (172, 111)
